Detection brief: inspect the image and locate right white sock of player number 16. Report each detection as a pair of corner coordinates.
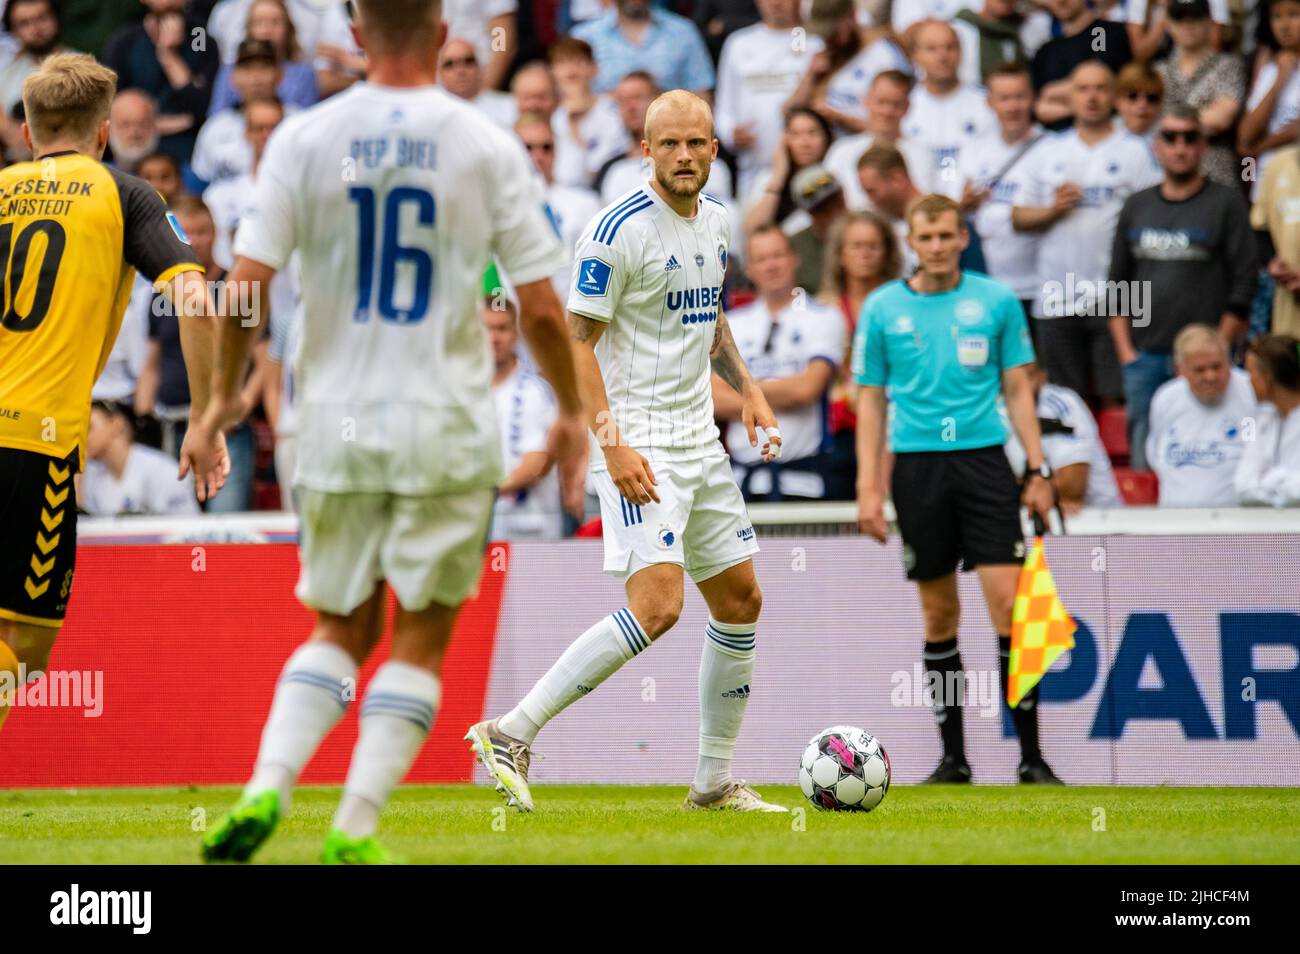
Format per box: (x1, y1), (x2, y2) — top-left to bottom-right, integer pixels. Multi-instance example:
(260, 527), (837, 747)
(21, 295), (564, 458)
(333, 659), (442, 838)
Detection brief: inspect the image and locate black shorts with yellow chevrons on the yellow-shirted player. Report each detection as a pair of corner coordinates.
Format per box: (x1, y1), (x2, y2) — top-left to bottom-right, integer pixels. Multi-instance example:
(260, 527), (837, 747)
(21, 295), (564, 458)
(0, 447), (78, 626)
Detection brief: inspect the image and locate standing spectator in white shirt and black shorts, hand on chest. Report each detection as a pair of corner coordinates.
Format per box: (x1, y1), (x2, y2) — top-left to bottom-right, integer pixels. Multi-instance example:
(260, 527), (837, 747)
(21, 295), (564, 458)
(1011, 62), (1161, 404)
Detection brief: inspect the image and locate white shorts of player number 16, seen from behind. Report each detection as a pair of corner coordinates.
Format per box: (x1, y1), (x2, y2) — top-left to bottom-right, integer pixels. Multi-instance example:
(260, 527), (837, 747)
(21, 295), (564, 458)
(296, 486), (497, 616)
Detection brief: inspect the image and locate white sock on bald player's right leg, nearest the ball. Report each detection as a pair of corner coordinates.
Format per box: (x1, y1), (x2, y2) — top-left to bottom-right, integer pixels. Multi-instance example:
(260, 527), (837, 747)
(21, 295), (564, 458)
(694, 617), (758, 794)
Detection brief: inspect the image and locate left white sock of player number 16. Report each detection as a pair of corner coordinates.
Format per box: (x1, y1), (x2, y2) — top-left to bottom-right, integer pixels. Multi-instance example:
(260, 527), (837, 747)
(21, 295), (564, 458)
(244, 641), (356, 814)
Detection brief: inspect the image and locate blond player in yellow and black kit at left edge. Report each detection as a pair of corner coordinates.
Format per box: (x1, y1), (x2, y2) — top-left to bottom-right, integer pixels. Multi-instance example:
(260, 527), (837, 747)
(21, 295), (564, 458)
(0, 55), (229, 738)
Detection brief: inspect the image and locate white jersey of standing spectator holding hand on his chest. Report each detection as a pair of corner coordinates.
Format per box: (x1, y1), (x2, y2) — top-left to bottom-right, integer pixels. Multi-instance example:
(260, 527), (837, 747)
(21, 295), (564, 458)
(1008, 123), (1162, 318)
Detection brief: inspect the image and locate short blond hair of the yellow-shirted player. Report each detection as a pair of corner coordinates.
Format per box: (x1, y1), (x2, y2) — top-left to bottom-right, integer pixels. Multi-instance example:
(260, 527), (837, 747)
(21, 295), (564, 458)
(22, 53), (117, 146)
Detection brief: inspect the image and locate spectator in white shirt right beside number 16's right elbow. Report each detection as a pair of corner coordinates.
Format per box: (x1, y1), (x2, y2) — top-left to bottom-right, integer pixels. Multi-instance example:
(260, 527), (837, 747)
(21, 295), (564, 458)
(481, 298), (563, 539)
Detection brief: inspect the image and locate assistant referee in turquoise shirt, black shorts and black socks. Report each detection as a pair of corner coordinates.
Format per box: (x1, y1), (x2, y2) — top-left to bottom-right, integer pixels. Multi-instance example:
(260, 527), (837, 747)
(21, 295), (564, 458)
(853, 195), (1060, 784)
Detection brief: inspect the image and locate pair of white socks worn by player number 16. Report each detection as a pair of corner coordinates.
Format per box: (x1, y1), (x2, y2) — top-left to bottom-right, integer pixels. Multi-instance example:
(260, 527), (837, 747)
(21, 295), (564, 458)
(244, 642), (442, 838)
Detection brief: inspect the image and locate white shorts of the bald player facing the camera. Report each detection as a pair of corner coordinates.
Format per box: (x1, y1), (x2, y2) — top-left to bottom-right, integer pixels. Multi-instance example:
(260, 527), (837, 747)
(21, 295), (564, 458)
(593, 454), (758, 582)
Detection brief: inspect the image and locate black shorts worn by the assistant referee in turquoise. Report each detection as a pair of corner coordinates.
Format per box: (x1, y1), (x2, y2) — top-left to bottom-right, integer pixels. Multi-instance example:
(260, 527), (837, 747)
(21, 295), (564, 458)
(891, 446), (1024, 582)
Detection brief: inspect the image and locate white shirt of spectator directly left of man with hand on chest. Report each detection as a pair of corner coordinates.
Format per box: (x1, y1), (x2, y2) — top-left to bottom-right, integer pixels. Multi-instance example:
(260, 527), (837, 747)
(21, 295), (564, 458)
(961, 129), (1044, 299)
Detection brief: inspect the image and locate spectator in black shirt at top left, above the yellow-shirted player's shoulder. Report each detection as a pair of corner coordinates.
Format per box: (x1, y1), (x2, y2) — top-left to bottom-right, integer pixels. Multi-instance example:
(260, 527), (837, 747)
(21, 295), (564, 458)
(101, 0), (221, 162)
